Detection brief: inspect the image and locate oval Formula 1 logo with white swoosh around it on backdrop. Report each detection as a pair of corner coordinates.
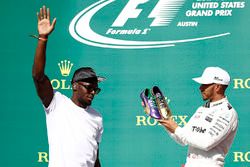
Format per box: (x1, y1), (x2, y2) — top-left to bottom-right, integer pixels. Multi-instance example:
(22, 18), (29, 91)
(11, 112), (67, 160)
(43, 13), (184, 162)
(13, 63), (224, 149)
(69, 0), (230, 49)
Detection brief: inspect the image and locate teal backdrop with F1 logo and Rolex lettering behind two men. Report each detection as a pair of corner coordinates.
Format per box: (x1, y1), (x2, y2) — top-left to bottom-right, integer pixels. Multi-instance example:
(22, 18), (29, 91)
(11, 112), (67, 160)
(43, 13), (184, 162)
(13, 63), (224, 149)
(0, 0), (250, 167)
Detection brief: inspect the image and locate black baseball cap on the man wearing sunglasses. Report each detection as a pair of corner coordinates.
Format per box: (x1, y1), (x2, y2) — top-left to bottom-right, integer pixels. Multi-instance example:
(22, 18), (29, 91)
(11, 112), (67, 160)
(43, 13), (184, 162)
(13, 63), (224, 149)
(71, 67), (106, 83)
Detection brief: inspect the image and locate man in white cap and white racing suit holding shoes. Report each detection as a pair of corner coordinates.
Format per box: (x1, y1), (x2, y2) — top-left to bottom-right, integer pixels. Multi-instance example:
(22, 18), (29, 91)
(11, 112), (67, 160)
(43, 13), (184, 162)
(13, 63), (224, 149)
(159, 67), (238, 167)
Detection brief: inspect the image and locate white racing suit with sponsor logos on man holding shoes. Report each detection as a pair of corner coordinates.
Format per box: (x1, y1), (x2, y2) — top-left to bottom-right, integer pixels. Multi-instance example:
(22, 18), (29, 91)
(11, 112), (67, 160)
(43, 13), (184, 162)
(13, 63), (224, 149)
(170, 98), (238, 167)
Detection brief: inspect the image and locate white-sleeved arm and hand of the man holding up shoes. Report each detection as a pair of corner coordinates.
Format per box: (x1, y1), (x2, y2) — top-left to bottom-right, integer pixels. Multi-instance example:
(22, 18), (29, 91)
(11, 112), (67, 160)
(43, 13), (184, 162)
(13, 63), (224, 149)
(160, 111), (237, 151)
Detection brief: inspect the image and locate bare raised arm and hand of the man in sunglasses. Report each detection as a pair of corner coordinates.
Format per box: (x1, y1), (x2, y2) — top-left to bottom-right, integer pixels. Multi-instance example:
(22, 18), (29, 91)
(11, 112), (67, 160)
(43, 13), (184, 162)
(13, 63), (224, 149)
(32, 6), (56, 107)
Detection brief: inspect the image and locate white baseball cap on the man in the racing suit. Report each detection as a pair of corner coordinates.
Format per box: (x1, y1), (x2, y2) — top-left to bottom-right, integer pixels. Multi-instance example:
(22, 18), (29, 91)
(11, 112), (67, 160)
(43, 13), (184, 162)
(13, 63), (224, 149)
(193, 67), (230, 85)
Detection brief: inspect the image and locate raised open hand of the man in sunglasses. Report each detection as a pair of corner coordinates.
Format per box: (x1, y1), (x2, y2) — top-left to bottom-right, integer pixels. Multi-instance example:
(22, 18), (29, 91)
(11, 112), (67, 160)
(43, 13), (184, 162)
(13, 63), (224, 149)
(37, 6), (56, 36)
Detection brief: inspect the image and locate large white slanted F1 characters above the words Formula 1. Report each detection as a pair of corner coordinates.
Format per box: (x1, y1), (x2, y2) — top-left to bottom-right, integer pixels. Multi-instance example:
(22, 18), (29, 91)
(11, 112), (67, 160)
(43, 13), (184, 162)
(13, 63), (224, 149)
(112, 0), (185, 27)
